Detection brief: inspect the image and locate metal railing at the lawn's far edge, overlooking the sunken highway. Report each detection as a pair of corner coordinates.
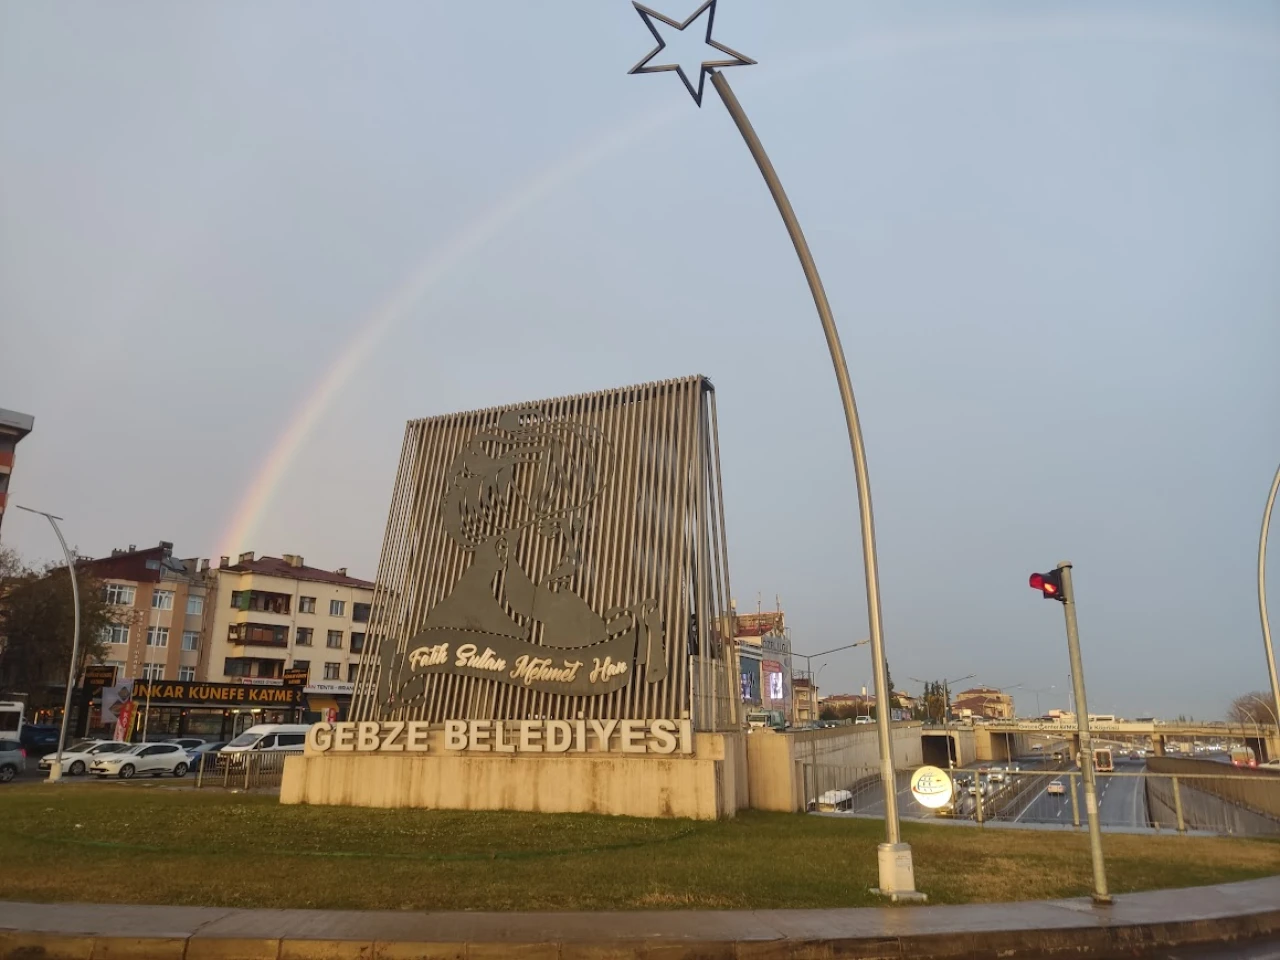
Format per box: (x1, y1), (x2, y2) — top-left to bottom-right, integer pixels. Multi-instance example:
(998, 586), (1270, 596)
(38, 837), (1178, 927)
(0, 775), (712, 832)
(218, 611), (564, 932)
(801, 759), (1280, 836)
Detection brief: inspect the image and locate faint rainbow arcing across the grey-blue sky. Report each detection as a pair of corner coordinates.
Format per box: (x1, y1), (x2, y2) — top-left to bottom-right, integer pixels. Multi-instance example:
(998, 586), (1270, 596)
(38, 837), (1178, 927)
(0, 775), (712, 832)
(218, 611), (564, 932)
(219, 14), (1280, 557)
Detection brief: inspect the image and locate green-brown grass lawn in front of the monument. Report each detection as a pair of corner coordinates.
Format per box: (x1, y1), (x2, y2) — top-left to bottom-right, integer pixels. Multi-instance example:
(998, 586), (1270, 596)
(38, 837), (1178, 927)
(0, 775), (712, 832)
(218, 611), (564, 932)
(0, 783), (1280, 910)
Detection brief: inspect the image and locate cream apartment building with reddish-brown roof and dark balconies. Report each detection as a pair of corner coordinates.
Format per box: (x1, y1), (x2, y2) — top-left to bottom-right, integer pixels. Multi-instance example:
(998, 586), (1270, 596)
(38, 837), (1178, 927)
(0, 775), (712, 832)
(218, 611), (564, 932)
(202, 552), (374, 713)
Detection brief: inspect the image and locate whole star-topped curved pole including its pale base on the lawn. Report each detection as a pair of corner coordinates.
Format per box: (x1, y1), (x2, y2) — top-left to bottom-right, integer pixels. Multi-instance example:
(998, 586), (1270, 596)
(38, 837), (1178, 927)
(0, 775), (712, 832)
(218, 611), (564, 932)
(630, 0), (918, 899)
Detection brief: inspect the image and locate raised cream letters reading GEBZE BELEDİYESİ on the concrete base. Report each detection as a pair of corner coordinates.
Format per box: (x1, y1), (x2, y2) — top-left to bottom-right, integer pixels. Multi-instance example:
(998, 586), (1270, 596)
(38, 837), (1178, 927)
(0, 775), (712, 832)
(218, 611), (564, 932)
(307, 719), (696, 757)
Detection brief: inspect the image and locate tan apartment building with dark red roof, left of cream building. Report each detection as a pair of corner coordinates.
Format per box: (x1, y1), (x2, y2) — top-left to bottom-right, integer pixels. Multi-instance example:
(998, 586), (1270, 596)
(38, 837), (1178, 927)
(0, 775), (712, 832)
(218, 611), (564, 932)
(77, 540), (209, 681)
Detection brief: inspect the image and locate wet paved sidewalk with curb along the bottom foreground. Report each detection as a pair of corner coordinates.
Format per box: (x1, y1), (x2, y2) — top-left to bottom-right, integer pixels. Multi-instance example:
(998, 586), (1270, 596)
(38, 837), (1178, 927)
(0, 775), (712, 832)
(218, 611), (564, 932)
(0, 877), (1280, 960)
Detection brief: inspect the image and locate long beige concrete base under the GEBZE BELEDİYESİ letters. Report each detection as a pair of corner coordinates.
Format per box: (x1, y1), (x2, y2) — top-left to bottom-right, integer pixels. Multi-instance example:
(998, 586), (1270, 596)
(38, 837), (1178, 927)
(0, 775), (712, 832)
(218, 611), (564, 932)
(280, 731), (748, 820)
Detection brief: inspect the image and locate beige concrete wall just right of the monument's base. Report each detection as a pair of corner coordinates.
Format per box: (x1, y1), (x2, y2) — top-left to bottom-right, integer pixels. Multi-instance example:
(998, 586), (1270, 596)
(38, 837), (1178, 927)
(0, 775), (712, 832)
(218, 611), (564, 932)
(746, 722), (923, 813)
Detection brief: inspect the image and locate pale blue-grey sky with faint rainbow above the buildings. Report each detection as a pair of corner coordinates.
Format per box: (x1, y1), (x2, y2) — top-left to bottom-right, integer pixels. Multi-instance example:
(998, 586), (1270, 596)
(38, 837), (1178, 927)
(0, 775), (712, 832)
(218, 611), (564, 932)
(0, 0), (1280, 717)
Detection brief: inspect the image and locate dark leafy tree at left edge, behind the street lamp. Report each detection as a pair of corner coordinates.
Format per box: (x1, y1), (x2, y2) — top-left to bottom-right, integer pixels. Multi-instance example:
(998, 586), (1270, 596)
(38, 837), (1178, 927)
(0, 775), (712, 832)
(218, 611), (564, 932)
(0, 550), (119, 709)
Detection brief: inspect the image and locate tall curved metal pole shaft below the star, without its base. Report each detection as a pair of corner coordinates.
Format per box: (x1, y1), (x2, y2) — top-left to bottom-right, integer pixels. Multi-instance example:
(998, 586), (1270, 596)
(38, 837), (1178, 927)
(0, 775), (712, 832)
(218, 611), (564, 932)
(710, 70), (905, 847)
